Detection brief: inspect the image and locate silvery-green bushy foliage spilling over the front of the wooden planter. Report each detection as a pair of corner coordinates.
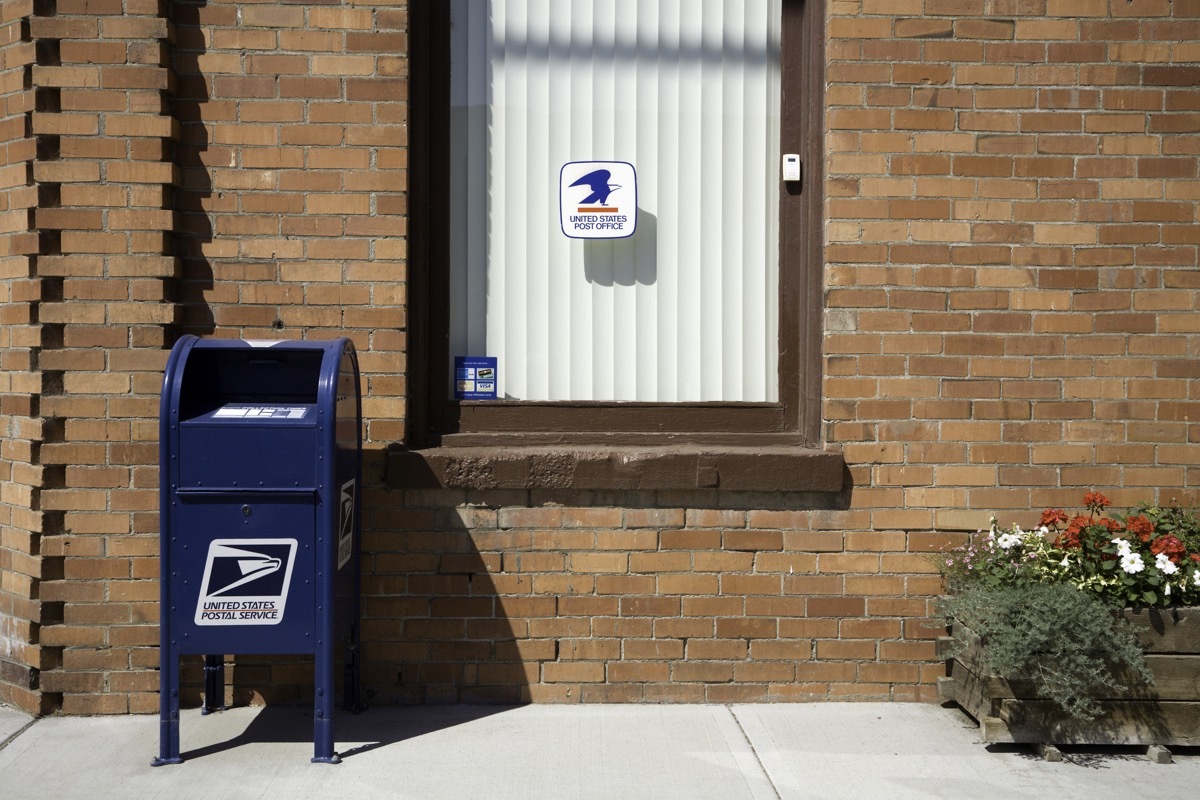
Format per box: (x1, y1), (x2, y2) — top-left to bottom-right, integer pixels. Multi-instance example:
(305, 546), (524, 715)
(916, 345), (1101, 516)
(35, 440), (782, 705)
(942, 583), (1151, 720)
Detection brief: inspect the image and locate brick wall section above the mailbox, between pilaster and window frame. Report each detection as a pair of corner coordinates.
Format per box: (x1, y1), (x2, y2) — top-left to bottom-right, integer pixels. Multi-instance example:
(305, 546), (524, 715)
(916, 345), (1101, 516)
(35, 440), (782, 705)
(172, 1), (408, 446)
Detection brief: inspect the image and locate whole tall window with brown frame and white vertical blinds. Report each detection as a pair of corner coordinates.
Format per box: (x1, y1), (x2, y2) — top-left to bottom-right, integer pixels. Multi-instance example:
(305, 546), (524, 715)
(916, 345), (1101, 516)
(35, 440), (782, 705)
(408, 0), (840, 491)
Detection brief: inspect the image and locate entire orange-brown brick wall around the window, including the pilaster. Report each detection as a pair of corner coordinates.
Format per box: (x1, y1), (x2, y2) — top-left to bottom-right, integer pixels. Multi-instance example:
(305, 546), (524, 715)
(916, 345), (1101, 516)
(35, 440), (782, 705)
(0, 0), (1200, 712)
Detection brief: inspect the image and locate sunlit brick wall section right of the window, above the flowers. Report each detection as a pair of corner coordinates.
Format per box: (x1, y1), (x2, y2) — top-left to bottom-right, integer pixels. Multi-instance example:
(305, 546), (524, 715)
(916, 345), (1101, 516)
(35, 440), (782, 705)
(824, 0), (1200, 520)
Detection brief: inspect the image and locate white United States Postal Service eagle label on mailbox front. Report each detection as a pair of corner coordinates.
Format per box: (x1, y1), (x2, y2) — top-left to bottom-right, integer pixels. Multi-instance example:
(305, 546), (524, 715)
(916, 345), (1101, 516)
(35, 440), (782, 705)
(196, 539), (296, 625)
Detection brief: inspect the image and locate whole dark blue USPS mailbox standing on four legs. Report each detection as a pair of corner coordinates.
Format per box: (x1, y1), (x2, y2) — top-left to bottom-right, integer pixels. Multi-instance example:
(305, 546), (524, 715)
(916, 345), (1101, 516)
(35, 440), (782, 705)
(154, 336), (362, 765)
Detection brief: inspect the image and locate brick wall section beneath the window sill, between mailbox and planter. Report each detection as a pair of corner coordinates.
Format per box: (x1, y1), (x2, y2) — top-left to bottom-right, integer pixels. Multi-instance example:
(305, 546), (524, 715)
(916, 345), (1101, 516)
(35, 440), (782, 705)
(364, 492), (943, 703)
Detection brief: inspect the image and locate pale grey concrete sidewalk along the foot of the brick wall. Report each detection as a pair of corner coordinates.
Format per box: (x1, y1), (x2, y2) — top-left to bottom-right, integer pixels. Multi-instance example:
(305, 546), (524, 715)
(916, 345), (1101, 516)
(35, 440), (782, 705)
(0, 703), (1200, 800)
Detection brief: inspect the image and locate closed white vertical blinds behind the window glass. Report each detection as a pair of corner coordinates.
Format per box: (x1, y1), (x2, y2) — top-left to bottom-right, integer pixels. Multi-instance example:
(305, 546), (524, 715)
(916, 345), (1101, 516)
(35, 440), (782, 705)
(450, 0), (781, 402)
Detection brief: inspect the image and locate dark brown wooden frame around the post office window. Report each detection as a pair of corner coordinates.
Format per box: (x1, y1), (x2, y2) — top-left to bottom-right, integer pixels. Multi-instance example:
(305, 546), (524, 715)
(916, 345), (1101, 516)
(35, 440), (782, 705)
(404, 0), (841, 488)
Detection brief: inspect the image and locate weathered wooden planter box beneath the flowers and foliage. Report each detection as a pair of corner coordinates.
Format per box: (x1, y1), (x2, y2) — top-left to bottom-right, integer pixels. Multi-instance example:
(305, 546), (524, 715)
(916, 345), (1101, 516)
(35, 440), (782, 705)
(937, 608), (1200, 747)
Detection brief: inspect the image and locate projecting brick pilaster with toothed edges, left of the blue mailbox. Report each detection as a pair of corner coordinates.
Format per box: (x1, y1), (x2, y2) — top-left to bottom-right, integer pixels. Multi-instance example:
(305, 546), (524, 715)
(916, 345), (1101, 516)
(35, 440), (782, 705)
(31, 0), (175, 714)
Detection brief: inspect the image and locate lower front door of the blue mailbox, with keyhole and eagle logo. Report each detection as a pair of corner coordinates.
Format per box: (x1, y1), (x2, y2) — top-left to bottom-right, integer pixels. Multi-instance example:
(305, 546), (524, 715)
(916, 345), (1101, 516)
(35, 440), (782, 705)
(170, 493), (316, 654)
